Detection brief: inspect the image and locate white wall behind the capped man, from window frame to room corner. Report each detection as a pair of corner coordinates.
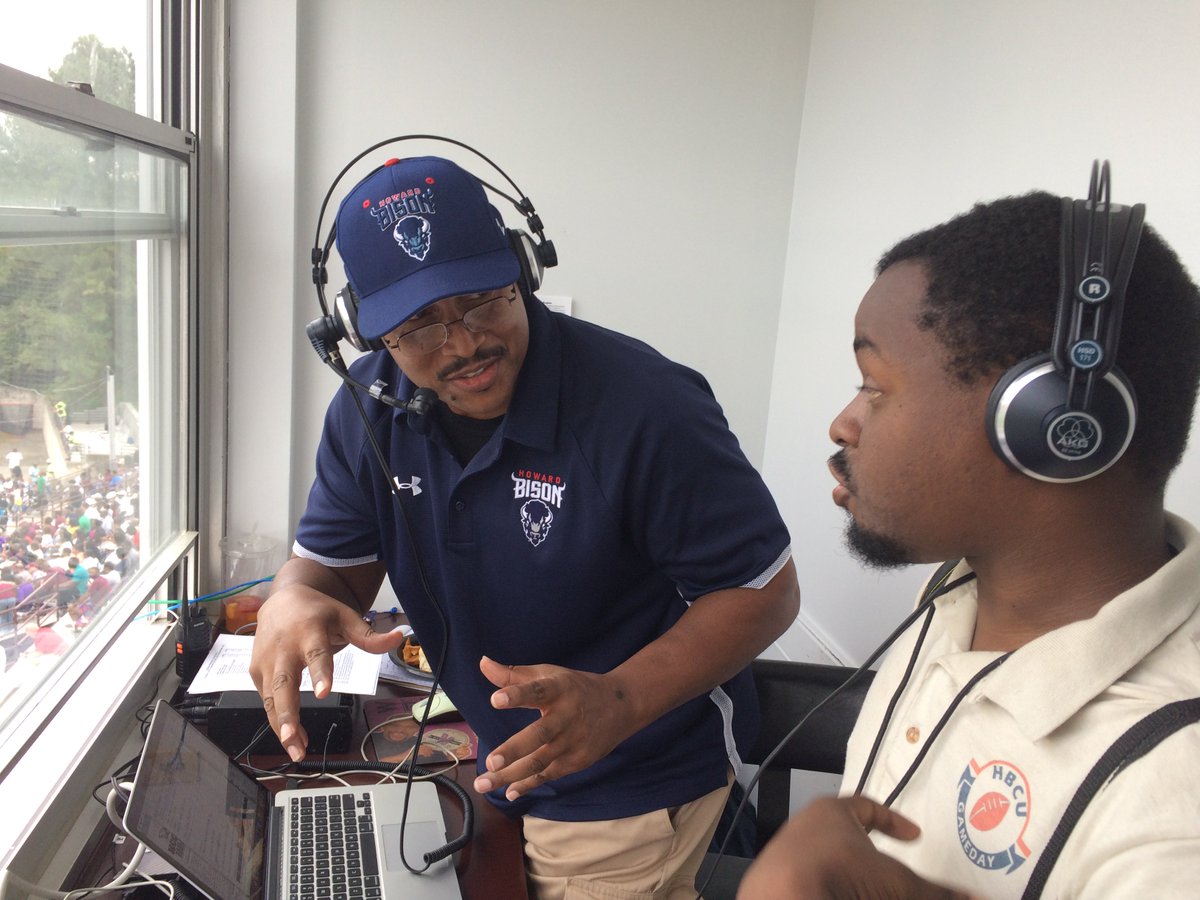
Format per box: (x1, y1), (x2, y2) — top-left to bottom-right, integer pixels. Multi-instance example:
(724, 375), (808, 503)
(228, 0), (812, 573)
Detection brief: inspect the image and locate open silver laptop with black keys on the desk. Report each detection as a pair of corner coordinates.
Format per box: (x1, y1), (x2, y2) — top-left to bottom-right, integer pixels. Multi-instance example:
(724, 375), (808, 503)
(125, 701), (462, 900)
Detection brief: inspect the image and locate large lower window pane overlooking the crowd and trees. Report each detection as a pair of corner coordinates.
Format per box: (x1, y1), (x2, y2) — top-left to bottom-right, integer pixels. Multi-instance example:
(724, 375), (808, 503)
(0, 108), (187, 739)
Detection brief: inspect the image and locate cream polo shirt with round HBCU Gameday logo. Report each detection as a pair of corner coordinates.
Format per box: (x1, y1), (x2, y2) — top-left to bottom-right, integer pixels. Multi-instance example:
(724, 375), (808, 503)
(841, 516), (1200, 900)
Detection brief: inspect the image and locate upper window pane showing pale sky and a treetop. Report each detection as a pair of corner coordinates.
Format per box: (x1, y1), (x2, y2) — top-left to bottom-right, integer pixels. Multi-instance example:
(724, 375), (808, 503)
(0, 0), (157, 118)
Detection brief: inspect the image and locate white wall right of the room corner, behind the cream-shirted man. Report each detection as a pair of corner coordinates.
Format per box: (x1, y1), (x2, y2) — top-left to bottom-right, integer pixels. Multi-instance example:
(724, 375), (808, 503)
(764, 0), (1200, 662)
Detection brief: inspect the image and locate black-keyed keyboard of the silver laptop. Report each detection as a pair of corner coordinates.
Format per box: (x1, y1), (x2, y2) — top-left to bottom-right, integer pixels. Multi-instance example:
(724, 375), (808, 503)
(287, 791), (383, 900)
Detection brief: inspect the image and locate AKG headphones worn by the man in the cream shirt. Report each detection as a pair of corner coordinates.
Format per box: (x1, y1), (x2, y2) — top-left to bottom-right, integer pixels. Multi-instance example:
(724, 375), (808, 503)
(986, 161), (1146, 484)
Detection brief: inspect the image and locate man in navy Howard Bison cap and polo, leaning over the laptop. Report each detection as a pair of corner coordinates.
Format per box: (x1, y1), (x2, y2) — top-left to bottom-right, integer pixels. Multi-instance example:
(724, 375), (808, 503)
(251, 157), (799, 898)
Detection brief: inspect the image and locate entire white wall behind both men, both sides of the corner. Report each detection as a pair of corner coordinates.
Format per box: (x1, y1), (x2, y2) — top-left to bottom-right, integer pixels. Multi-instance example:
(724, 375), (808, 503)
(229, 0), (1200, 661)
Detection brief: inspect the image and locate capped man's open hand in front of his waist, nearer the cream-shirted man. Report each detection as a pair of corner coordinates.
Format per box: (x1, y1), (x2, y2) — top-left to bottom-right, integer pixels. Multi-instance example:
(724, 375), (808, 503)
(475, 656), (637, 800)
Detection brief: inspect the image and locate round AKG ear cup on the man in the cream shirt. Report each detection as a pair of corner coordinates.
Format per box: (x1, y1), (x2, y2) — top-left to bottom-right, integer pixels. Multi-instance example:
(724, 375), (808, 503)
(985, 354), (1138, 484)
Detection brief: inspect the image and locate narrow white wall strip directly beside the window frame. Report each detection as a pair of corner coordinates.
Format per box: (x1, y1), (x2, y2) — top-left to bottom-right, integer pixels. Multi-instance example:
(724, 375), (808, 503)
(225, 0), (298, 571)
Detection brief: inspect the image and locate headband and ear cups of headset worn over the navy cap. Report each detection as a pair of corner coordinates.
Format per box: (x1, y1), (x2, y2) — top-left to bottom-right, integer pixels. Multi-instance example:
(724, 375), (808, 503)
(308, 134), (558, 359)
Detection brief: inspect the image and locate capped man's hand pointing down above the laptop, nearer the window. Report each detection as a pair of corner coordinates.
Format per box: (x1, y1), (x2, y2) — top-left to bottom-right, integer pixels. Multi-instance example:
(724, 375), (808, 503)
(250, 559), (404, 762)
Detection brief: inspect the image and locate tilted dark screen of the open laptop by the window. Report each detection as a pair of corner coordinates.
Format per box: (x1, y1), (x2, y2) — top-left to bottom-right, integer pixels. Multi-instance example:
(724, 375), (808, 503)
(125, 701), (271, 900)
